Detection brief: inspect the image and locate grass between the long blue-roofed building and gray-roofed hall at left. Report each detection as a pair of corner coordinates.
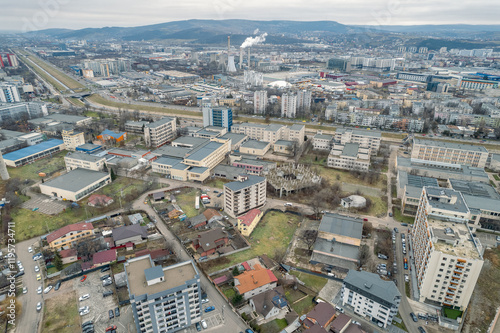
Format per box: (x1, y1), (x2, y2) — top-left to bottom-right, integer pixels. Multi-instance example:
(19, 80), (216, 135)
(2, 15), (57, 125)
(7, 150), (67, 181)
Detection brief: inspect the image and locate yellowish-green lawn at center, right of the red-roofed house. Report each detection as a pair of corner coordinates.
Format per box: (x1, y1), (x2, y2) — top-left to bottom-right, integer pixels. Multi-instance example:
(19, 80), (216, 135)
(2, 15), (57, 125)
(206, 211), (300, 273)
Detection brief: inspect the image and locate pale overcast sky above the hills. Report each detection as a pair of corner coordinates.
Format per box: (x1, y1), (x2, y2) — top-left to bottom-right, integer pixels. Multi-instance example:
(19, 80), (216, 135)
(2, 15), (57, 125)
(0, 0), (500, 30)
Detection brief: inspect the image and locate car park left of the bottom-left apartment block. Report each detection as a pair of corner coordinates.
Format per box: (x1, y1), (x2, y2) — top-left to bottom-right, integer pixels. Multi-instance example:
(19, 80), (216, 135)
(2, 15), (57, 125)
(73, 270), (136, 333)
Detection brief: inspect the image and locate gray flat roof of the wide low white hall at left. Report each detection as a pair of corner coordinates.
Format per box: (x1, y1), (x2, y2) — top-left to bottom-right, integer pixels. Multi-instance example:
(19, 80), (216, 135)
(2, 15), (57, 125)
(42, 168), (110, 192)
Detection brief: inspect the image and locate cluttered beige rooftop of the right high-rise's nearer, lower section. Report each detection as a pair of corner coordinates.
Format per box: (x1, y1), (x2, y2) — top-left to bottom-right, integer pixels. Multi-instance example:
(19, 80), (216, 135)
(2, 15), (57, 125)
(428, 218), (482, 259)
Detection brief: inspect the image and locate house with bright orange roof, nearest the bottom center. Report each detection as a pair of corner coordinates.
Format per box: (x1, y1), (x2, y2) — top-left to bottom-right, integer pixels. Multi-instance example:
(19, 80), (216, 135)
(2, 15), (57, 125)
(234, 264), (278, 300)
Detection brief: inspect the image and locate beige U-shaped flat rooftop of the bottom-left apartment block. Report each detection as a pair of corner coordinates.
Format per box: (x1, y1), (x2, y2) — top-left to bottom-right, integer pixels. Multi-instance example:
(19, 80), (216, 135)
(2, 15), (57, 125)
(124, 255), (198, 295)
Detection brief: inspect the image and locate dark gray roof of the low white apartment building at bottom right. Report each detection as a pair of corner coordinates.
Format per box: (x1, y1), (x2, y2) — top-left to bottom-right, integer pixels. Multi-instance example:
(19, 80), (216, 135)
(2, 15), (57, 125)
(344, 269), (401, 308)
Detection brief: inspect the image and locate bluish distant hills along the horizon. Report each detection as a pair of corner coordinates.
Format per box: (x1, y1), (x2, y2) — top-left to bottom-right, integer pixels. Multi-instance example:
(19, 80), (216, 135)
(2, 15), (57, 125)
(26, 19), (500, 44)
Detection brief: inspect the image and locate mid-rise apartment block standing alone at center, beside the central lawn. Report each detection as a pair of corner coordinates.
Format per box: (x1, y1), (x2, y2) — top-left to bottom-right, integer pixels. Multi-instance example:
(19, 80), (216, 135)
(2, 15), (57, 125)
(224, 175), (267, 217)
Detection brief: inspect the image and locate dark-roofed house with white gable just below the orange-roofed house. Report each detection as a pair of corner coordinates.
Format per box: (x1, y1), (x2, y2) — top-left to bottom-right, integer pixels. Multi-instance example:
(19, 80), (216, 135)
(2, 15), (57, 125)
(249, 286), (288, 321)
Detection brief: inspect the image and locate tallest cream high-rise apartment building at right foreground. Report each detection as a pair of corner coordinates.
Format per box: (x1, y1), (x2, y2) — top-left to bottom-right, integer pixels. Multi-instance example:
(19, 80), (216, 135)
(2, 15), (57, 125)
(411, 186), (483, 310)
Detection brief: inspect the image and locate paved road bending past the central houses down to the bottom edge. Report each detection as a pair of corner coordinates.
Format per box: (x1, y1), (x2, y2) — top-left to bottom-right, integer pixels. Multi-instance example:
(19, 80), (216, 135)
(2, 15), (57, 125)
(132, 181), (247, 332)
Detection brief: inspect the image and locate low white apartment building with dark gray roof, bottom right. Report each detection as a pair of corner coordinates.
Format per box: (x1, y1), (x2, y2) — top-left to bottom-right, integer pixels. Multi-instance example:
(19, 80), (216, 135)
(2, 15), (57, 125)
(340, 269), (401, 328)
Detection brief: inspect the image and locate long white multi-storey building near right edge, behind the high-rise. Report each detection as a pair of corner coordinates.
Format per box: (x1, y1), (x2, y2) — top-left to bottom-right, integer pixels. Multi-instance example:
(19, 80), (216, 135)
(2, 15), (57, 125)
(411, 138), (488, 168)
